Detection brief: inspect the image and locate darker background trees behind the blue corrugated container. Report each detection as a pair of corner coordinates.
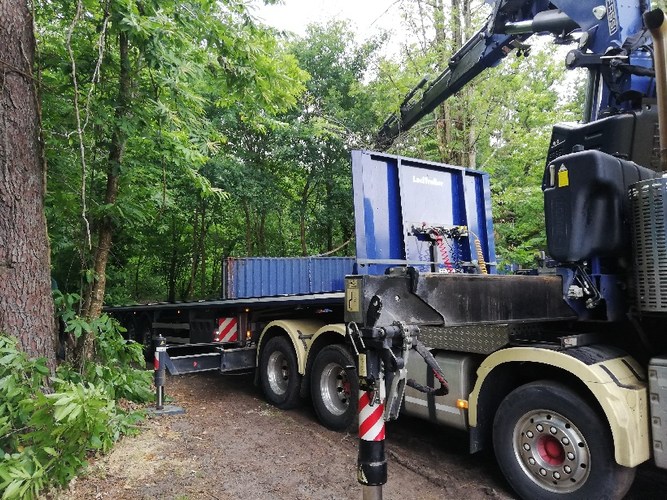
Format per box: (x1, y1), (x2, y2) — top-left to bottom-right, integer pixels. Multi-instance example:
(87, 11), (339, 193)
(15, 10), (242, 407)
(60, 18), (378, 304)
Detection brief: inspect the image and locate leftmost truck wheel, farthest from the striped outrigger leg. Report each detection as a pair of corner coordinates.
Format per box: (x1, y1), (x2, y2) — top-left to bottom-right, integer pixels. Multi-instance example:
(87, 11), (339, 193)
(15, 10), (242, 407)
(259, 337), (301, 410)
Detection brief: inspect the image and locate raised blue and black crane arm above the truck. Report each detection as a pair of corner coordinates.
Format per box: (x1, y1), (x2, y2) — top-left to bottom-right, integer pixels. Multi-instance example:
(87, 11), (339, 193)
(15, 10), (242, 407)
(376, 0), (652, 150)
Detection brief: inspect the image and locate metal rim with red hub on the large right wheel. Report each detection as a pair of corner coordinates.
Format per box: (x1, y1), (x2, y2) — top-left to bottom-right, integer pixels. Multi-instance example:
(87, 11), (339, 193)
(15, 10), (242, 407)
(513, 410), (591, 493)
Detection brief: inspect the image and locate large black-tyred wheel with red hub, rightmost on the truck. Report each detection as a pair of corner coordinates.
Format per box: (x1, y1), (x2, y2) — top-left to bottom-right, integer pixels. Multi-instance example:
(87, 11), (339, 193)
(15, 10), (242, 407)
(493, 380), (635, 499)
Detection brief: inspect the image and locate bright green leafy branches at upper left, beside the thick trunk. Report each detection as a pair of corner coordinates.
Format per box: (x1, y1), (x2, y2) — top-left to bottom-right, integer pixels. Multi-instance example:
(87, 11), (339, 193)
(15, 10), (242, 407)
(41, 0), (307, 302)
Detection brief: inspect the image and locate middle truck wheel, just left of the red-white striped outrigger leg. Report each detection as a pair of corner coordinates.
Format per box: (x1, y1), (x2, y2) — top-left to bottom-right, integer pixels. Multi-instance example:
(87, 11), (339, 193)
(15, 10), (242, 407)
(310, 345), (359, 431)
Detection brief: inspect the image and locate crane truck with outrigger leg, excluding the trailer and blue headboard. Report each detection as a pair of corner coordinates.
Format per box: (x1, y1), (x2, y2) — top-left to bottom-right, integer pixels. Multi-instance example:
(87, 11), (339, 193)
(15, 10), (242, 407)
(352, 0), (667, 499)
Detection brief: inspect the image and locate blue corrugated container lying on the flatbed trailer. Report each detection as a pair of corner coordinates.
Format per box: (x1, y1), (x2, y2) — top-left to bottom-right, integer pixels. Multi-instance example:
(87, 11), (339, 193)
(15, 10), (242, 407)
(223, 257), (354, 299)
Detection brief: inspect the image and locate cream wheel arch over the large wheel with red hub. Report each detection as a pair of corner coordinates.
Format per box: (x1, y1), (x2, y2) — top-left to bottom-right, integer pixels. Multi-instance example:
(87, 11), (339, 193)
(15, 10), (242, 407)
(468, 345), (650, 467)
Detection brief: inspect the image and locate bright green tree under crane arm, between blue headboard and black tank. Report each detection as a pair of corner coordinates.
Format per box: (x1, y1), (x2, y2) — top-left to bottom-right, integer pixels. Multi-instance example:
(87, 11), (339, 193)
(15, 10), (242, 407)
(478, 50), (584, 267)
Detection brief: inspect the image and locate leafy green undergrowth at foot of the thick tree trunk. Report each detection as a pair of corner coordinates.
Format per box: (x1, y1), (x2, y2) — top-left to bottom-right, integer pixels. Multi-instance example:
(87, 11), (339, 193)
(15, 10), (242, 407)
(0, 296), (153, 500)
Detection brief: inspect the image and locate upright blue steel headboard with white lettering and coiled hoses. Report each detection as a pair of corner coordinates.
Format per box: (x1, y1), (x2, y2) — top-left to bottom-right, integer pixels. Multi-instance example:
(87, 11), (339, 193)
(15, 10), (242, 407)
(352, 151), (495, 274)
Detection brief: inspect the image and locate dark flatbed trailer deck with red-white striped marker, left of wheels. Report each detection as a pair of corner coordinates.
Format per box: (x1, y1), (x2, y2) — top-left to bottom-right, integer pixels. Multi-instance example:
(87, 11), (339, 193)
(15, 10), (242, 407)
(109, 292), (344, 375)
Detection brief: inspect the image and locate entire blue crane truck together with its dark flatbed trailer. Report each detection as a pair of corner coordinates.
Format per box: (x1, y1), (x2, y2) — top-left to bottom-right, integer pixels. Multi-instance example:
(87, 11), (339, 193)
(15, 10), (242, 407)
(109, 0), (667, 499)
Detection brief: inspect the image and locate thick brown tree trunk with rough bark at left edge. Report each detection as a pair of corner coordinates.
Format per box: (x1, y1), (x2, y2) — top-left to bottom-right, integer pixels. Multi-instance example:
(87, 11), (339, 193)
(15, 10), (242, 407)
(0, 0), (56, 368)
